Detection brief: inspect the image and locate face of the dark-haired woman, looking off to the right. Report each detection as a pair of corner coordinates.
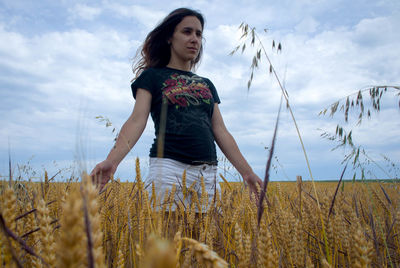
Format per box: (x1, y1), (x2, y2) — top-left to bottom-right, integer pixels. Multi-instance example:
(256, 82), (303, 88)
(169, 16), (203, 67)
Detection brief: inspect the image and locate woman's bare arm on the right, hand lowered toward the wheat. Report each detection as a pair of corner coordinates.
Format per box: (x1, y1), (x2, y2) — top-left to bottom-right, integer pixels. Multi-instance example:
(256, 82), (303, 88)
(212, 103), (261, 196)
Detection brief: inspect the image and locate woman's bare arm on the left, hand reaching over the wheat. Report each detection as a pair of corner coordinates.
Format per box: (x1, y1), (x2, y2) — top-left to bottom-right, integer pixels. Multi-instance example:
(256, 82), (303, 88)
(90, 88), (151, 191)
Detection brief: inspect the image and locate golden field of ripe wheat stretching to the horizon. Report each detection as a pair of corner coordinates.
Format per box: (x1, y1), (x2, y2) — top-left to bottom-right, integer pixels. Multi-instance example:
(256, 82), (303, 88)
(0, 158), (400, 267)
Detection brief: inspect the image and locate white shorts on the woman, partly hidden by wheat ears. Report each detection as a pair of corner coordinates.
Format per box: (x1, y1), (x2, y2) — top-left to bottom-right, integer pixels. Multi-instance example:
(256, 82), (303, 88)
(145, 157), (221, 212)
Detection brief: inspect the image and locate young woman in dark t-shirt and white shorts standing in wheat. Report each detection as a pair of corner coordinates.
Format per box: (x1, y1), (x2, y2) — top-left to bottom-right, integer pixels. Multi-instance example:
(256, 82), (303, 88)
(91, 8), (261, 207)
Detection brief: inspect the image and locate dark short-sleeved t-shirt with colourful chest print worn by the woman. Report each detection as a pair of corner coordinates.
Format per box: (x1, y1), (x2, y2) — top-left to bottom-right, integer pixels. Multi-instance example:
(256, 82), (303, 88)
(131, 67), (220, 165)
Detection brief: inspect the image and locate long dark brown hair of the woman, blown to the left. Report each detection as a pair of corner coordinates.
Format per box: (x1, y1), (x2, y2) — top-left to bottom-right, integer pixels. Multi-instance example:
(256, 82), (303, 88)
(133, 8), (204, 78)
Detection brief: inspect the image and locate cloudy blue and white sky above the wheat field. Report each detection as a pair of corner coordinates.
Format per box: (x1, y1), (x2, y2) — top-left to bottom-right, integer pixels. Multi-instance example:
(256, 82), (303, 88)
(0, 0), (400, 181)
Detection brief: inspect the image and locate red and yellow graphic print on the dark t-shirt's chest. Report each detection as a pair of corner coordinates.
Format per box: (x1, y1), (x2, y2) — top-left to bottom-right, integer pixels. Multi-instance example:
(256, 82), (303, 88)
(162, 73), (212, 109)
